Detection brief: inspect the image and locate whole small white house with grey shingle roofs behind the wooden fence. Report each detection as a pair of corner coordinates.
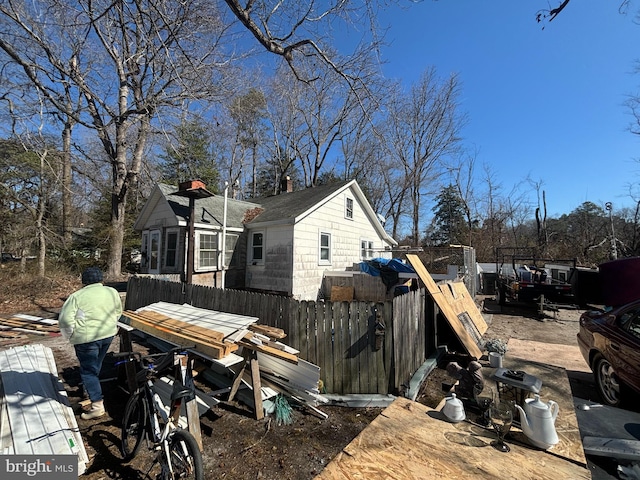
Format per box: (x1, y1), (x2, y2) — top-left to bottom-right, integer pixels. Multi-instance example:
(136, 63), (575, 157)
(135, 180), (397, 299)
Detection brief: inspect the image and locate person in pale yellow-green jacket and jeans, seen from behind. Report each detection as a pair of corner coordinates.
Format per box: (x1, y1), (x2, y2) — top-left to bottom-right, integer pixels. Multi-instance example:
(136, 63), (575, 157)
(58, 267), (122, 420)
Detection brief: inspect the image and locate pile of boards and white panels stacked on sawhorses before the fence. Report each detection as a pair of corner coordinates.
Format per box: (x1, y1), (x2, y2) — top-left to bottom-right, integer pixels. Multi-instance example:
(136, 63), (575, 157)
(123, 302), (328, 418)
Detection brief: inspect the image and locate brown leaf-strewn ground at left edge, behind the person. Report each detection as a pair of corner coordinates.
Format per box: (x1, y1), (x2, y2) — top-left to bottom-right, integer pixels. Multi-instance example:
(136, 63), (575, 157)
(0, 263), (82, 314)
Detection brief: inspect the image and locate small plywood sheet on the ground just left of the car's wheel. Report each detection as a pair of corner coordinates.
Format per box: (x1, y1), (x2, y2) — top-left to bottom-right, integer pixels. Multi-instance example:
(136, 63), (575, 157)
(506, 338), (591, 373)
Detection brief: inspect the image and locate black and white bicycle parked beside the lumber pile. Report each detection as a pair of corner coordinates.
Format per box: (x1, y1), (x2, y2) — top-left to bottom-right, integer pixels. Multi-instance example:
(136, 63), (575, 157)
(116, 347), (204, 480)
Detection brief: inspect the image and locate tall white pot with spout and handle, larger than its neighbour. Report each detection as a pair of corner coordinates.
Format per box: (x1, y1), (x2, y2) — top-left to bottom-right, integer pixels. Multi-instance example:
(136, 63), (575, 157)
(516, 395), (560, 450)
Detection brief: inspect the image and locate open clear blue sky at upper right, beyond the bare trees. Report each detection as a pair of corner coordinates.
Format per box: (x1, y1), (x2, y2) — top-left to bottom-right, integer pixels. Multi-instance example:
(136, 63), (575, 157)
(381, 0), (640, 216)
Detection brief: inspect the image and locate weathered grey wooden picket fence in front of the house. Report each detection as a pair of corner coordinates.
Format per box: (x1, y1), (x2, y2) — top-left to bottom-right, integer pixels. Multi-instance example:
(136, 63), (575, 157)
(125, 277), (433, 394)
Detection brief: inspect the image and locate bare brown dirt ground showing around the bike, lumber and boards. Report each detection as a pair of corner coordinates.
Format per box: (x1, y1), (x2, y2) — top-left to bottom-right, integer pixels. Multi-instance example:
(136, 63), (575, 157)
(0, 278), (595, 480)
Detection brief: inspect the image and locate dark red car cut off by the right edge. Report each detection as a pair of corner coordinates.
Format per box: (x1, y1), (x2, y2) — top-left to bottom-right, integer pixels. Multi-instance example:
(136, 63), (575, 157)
(578, 300), (640, 407)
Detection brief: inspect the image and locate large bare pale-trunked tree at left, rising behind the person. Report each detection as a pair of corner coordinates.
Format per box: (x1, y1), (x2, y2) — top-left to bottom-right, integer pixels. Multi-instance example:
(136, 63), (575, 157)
(0, 0), (235, 277)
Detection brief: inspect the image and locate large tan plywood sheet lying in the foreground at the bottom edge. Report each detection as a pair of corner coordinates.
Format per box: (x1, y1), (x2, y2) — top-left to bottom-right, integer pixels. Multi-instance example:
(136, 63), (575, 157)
(315, 397), (591, 480)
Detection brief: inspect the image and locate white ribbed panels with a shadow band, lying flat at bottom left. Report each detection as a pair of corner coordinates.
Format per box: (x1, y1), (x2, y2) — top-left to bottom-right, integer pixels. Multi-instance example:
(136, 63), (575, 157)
(0, 344), (89, 475)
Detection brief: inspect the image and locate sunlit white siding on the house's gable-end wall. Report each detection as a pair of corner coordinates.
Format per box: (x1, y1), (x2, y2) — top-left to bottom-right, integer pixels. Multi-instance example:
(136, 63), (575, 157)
(291, 190), (391, 300)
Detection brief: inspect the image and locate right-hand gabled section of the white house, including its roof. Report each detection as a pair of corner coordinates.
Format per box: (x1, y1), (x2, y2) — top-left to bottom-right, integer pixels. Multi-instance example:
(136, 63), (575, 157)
(246, 181), (396, 299)
